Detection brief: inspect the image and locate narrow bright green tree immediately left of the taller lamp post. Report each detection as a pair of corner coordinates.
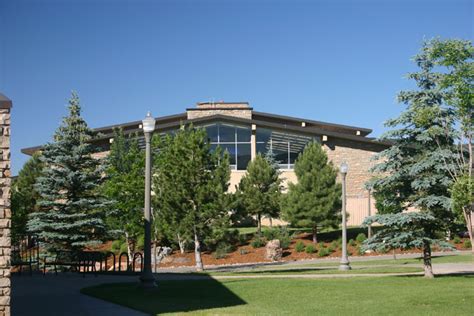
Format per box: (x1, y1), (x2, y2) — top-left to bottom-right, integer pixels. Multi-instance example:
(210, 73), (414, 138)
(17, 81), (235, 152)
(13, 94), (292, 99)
(103, 129), (145, 260)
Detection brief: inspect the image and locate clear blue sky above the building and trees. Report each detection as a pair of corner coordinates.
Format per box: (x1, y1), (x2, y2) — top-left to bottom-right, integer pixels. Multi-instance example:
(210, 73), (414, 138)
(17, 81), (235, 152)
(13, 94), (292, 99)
(0, 0), (474, 174)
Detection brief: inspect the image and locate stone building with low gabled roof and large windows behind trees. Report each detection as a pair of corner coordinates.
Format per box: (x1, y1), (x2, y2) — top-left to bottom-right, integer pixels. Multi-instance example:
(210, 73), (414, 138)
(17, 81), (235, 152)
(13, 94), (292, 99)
(22, 102), (389, 225)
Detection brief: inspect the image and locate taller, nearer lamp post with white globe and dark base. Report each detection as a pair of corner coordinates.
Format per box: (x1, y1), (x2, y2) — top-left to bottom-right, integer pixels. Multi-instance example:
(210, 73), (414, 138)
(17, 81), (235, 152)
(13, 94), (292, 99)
(140, 112), (156, 288)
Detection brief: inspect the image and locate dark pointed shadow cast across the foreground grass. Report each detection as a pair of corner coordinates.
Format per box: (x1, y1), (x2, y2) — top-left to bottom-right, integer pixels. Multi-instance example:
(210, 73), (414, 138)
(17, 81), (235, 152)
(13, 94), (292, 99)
(81, 275), (247, 315)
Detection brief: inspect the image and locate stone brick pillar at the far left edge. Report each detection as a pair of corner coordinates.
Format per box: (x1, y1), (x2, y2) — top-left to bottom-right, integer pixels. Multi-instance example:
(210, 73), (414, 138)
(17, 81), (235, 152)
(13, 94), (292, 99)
(0, 93), (12, 316)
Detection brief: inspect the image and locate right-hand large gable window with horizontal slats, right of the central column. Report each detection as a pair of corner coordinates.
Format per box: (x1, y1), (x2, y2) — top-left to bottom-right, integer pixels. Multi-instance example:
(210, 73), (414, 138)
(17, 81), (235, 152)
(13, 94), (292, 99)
(257, 128), (313, 169)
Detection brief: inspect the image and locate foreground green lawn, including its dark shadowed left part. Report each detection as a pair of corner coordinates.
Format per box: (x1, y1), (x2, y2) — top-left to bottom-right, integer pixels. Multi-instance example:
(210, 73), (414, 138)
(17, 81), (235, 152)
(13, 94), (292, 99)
(82, 276), (474, 315)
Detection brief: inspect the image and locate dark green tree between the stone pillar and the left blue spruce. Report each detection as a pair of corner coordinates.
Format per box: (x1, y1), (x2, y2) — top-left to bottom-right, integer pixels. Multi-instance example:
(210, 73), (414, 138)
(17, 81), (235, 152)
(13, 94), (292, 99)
(11, 153), (43, 242)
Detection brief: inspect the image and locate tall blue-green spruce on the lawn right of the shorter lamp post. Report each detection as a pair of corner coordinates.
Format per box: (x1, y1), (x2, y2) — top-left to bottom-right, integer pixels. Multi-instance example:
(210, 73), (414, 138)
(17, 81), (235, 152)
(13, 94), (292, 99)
(368, 43), (454, 277)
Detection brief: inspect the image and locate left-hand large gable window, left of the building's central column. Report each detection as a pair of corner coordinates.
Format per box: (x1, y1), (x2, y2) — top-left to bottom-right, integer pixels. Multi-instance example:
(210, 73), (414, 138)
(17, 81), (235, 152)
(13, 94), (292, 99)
(204, 123), (252, 170)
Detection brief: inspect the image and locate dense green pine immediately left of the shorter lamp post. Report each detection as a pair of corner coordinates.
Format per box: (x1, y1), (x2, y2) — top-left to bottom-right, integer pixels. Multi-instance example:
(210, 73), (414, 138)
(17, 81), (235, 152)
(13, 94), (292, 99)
(282, 142), (341, 243)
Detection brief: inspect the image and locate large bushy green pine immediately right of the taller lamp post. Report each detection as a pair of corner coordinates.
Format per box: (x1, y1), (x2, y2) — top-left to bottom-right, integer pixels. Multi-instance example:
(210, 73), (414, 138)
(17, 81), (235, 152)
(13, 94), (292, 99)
(154, 126), (230, 271)
